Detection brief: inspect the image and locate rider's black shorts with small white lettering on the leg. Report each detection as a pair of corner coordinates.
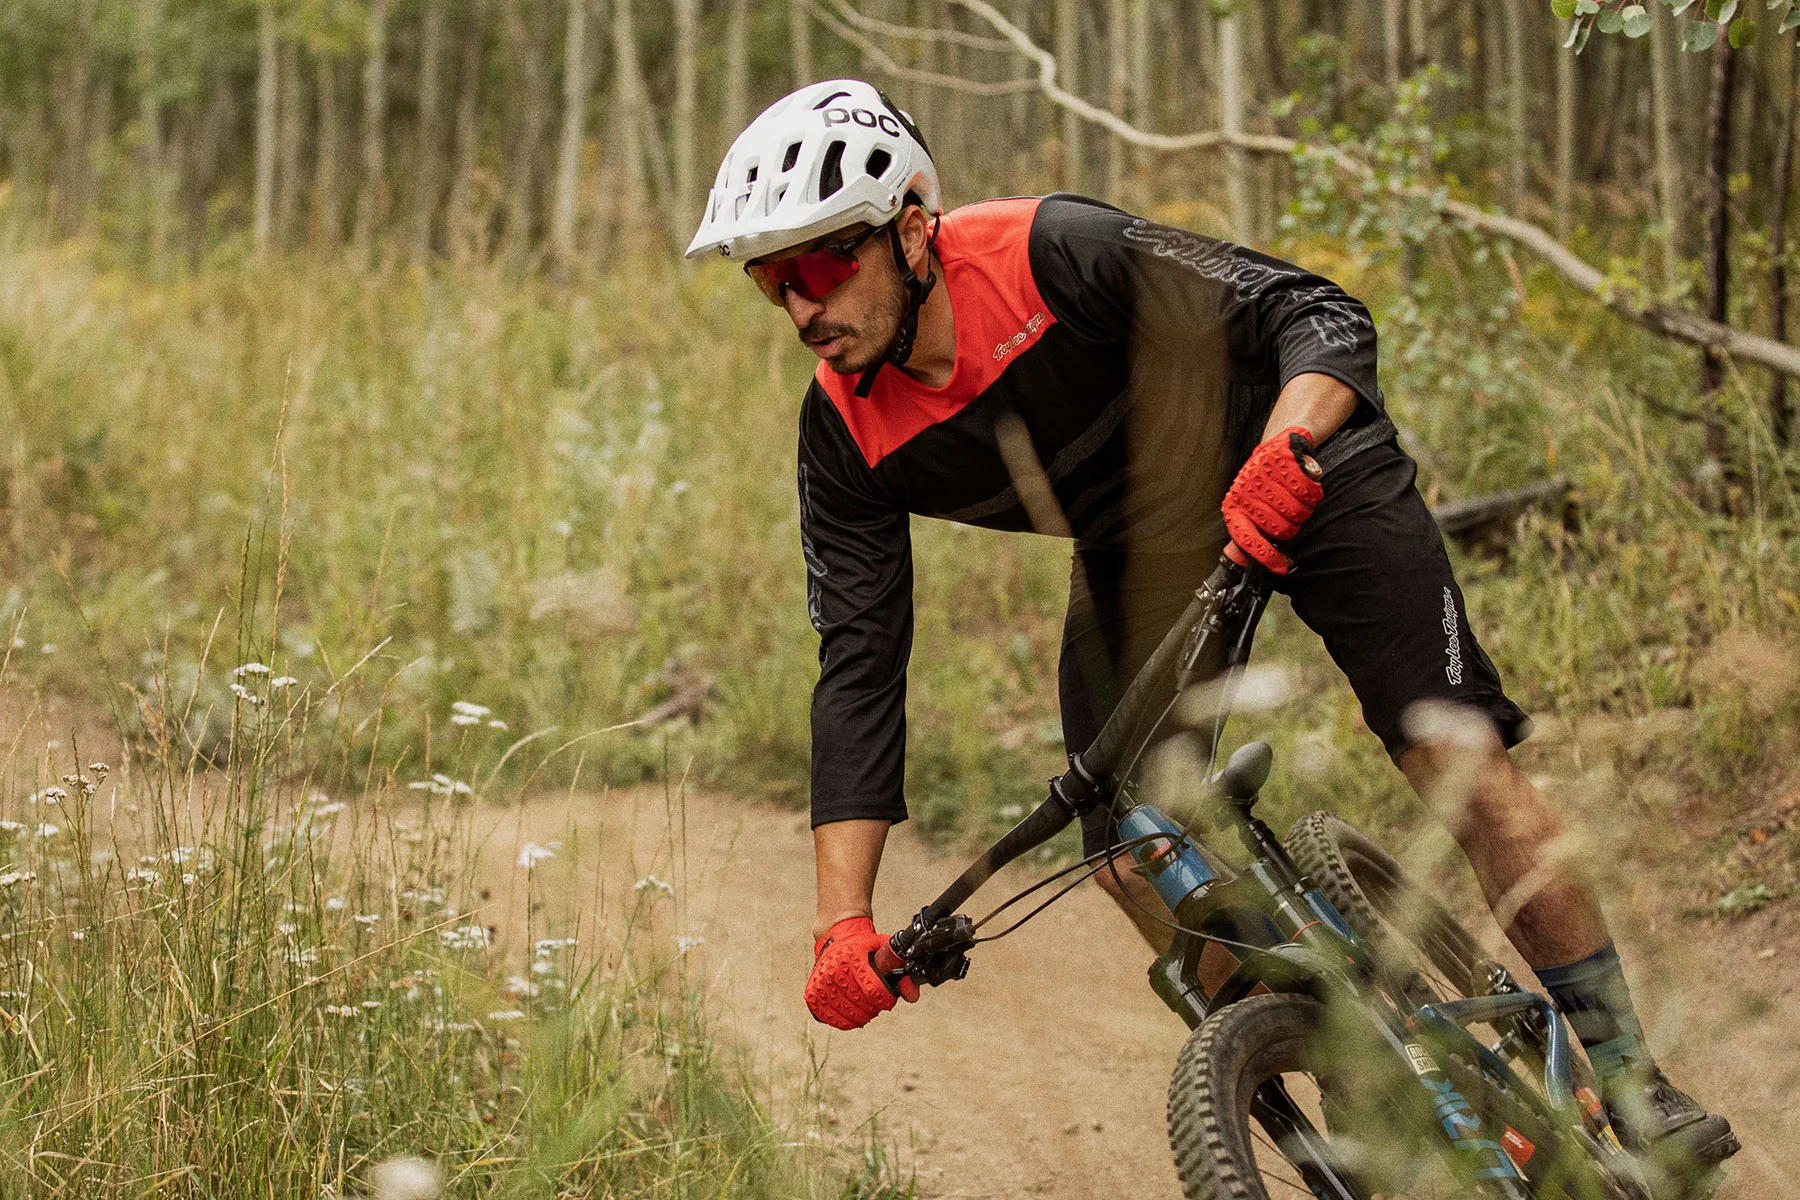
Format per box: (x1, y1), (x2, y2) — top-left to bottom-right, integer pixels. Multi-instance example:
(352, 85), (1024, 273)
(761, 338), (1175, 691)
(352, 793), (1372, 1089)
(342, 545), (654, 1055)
(1058, 439), (1530, 853)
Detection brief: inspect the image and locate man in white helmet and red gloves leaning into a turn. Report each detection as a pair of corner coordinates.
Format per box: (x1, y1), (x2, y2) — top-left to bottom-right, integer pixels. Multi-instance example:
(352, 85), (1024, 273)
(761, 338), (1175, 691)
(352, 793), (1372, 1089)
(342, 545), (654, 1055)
(688, 79), (1737, 1166)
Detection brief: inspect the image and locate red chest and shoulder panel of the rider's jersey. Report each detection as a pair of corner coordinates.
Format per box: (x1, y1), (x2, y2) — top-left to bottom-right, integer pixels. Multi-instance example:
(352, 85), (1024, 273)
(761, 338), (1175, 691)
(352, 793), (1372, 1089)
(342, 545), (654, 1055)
(814, 196), (1057, 468)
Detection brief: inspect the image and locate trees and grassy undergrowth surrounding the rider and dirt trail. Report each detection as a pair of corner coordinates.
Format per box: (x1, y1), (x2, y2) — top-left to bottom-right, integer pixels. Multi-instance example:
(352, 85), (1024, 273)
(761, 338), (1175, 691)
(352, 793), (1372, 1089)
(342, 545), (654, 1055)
(0, 0), (1800, 1195)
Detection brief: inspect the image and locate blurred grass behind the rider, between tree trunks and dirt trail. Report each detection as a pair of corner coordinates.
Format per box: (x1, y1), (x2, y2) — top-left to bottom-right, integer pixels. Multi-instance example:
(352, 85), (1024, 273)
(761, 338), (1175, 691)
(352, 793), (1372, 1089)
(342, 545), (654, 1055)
(0, 199), (1800, 892)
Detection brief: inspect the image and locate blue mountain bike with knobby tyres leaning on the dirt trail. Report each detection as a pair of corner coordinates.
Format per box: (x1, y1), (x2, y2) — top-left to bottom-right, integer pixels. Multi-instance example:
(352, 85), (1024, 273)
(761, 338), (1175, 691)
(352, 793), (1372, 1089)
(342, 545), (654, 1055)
(875, 558), (1667, 1200)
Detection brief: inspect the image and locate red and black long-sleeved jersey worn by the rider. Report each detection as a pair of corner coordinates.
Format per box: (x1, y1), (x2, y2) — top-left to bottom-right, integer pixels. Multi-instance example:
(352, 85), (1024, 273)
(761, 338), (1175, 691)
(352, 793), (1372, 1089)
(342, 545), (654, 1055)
(799, 194), (1393, 826)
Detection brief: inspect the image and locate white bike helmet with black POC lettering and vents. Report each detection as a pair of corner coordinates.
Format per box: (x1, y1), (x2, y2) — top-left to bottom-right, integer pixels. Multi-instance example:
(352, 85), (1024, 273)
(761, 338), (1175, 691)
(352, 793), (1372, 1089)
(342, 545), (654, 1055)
(688, 79), (941, 263)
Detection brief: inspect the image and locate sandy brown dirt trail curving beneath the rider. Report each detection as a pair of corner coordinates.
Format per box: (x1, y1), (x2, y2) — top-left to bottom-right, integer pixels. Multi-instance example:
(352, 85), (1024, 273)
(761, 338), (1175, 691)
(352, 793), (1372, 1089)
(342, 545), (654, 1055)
(490, 792), (1800, 1200)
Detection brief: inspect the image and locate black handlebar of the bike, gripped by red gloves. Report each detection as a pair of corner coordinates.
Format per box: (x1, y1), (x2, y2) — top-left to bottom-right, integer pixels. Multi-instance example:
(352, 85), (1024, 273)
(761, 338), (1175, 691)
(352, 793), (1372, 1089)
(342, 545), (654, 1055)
(875, 545), (1269, 984)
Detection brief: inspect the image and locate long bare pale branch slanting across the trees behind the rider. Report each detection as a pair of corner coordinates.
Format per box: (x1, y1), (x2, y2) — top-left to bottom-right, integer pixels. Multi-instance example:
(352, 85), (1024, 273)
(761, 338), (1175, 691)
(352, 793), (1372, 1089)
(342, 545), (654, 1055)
(871, 0), (1800, 380)
